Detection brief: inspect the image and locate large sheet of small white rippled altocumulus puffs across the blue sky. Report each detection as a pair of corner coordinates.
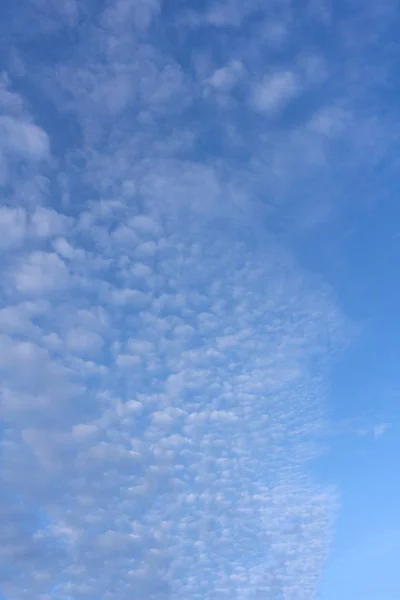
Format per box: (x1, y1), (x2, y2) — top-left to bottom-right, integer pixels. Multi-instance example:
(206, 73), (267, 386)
(0, 0), (390, 600)
